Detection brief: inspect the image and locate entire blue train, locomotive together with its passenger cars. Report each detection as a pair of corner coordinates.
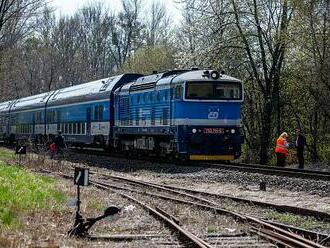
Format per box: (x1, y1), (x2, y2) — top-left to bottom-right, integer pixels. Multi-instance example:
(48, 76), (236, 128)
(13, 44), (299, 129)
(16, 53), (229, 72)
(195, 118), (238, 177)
(0, 69), (243, 160)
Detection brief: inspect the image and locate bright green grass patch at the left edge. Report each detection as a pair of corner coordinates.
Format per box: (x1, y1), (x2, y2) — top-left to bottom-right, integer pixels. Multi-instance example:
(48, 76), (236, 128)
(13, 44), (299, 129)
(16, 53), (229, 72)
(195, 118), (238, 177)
(0, 150), (66, 229)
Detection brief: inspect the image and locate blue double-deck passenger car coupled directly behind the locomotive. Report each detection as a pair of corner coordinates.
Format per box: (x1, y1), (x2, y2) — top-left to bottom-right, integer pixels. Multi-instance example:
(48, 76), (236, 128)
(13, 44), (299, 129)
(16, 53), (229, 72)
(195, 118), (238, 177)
(46, 74), (141, 147)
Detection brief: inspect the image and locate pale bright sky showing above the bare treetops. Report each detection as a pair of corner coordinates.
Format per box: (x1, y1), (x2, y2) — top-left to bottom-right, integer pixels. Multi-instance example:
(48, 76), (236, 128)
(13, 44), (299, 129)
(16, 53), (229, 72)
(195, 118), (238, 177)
(50, 0), (181, 25)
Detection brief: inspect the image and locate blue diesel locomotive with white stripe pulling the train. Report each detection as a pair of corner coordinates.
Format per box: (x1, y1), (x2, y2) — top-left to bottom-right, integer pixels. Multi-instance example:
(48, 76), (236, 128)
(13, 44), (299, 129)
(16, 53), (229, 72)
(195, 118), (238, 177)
(114, 70), (243, 160)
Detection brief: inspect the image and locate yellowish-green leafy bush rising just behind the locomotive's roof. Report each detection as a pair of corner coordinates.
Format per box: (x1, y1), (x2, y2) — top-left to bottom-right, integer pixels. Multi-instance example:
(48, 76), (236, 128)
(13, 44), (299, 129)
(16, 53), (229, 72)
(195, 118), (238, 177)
(122, 46), (175, 74)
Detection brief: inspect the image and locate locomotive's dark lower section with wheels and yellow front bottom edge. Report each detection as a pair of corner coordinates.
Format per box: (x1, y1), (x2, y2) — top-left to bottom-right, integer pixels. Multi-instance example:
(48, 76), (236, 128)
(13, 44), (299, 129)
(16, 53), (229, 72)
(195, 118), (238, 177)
(114, 127), (243, 161)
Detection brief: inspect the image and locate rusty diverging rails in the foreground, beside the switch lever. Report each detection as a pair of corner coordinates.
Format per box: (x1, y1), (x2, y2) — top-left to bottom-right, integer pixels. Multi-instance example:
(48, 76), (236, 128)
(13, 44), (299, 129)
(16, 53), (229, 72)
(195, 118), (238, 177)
(42, 171), (329, 247)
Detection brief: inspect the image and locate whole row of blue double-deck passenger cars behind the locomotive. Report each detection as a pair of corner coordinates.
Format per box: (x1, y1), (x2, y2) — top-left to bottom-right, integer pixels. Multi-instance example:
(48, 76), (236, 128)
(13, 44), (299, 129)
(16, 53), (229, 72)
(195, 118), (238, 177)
(0, 74), (141, 146)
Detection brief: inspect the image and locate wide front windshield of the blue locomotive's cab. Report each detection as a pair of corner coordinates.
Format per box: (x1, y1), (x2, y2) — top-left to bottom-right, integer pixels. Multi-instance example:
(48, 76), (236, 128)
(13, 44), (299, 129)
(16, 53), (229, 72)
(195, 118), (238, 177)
(186, 82), (242, 100)
